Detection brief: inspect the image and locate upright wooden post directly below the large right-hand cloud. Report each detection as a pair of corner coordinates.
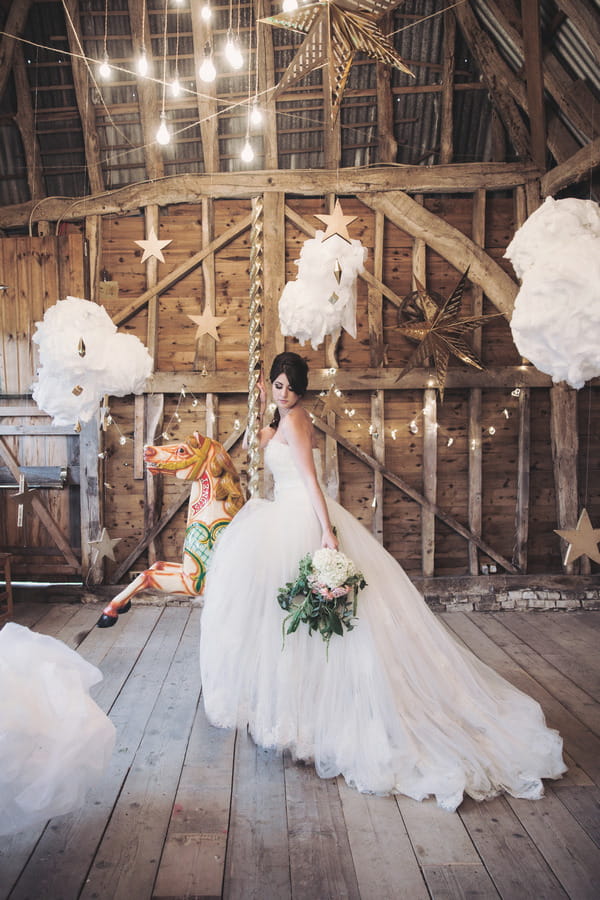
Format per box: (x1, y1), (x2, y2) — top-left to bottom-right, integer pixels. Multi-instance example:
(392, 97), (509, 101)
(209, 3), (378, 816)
(550, 381), (579, 575)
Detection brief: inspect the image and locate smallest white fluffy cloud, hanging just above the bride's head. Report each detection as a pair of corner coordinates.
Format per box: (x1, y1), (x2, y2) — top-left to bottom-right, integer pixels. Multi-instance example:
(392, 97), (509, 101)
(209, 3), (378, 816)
(279, 231), (367, 350)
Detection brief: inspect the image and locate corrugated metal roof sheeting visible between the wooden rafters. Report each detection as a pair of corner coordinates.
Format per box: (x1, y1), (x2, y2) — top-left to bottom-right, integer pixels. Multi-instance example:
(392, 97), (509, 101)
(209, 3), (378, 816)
(0, 0), (600, 213)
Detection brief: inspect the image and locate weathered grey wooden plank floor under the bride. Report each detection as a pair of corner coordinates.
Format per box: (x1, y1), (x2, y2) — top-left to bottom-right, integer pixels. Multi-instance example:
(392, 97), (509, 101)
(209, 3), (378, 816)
(0, 601), (600, 900)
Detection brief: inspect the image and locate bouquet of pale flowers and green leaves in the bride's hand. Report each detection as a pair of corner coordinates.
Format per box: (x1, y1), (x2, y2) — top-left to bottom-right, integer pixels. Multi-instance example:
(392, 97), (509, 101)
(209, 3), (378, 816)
(277, 549), (366, 651)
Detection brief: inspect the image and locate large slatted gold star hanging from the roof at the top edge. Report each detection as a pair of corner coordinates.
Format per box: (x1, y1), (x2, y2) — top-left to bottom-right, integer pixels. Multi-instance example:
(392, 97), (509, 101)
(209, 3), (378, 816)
(259, 0), (413, 121)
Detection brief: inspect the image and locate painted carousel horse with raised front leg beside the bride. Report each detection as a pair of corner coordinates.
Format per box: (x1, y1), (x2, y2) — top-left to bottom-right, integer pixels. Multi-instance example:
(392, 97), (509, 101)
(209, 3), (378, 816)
(97, 432), (244, 628)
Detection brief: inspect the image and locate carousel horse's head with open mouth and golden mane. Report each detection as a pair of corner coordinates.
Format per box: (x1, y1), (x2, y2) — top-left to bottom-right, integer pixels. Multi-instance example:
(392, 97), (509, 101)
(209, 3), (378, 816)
(144, 431), (244, 517)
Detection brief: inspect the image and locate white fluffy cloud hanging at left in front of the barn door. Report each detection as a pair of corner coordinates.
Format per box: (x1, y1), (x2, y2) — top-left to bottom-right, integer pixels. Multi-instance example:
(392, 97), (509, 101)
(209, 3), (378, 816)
(33, 297), (152, 425)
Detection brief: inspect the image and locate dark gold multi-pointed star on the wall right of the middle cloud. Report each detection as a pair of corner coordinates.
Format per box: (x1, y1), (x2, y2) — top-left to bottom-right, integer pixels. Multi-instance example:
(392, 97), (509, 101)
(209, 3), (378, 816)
(397, 269), (502, 401)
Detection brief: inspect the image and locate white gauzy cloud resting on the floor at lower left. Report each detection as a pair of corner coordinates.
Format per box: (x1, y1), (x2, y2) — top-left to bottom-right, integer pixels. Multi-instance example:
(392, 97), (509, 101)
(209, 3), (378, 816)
(0, 622), (115, 835)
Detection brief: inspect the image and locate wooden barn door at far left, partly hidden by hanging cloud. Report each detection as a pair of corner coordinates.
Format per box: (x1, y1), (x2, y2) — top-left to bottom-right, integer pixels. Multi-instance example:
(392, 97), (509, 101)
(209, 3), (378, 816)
(0, 233), (86, 581)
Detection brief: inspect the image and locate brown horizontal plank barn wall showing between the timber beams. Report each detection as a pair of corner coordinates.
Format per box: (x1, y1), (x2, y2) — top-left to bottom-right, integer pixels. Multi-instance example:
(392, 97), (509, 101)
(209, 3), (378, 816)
(0, 195), (600, 580)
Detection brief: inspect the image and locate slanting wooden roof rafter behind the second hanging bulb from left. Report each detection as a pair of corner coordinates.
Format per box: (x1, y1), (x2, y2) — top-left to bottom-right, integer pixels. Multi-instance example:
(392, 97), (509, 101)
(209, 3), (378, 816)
(127, 0), (165, 180)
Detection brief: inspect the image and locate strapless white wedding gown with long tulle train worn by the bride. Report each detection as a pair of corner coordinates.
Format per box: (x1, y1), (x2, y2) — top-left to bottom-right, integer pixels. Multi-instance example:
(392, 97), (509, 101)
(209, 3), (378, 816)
(200, 439), (566, 810)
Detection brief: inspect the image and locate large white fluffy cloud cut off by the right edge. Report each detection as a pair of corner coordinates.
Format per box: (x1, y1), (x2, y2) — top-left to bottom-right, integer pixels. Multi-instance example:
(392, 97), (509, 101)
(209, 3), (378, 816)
(505, 197), (600, 388)
